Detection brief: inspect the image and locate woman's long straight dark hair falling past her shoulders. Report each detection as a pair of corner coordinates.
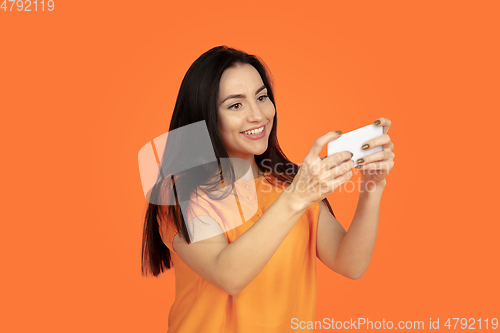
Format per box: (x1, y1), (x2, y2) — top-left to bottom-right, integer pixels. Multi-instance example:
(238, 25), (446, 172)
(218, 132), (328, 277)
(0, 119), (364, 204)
(141, 45), (335, 276)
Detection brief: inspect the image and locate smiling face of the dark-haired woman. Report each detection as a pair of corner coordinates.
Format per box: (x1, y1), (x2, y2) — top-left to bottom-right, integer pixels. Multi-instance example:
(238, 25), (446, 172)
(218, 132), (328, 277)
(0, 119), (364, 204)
(218, 64), (276, 162)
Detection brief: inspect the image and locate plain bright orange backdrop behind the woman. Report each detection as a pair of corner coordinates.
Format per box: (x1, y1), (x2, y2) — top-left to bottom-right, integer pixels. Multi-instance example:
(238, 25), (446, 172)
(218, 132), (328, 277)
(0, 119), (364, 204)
(0, 0), (500, 332)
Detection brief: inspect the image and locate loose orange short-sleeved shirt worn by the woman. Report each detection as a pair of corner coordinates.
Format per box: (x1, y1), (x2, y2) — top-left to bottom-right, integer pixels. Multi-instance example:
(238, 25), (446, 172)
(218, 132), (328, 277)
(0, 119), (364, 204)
(160, 176), (319, 333)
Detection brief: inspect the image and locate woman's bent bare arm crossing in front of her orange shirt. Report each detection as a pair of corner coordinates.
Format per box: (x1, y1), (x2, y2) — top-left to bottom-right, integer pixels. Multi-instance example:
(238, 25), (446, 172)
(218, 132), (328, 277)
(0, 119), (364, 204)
(173, 192), (306, 295)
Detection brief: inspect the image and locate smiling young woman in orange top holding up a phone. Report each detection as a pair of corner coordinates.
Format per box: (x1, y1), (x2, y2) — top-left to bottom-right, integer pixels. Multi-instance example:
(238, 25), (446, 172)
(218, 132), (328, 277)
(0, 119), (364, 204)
(142, 46), (395, 333)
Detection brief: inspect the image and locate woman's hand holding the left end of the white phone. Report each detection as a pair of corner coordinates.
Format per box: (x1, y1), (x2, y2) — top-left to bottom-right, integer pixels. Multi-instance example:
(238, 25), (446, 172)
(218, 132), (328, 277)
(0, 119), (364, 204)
(285, 131), (354, 209)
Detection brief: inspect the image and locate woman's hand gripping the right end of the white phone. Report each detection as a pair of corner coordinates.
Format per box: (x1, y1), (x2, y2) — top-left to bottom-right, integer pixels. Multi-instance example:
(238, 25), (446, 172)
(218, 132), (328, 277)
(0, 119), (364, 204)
(356, 118), (396, 186)
